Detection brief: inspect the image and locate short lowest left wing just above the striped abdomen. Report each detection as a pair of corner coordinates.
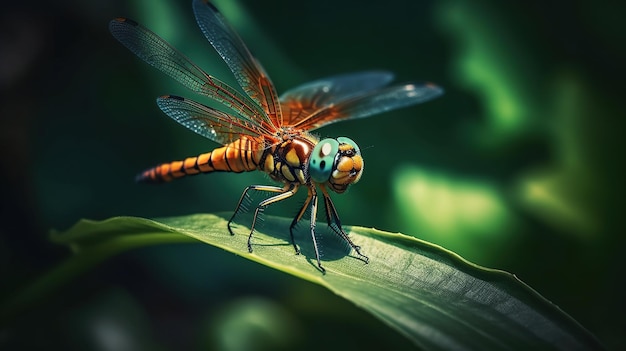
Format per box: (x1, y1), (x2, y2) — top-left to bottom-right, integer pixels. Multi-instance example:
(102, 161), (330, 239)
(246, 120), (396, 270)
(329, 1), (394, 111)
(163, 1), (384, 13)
(157, 95), (268, 145)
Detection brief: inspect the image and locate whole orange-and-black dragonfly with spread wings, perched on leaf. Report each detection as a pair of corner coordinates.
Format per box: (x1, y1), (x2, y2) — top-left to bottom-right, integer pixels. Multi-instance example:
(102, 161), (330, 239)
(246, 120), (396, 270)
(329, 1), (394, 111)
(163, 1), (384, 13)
(109, 0), (443, 273)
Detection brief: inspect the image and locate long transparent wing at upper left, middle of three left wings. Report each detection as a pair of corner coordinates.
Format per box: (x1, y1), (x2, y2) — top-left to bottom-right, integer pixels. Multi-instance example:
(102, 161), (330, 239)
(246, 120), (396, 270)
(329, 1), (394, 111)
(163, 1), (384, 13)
(109, 18), (269, 129)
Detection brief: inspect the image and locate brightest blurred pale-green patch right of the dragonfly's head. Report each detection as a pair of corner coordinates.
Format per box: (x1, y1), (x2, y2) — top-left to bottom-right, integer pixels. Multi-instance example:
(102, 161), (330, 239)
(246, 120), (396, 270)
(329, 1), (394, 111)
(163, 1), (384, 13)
(393, 166), (515, 260)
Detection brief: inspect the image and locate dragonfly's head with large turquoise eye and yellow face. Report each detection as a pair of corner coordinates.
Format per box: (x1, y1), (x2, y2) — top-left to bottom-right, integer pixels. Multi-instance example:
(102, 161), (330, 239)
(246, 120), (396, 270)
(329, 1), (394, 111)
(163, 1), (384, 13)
(309, 137), (363, 193)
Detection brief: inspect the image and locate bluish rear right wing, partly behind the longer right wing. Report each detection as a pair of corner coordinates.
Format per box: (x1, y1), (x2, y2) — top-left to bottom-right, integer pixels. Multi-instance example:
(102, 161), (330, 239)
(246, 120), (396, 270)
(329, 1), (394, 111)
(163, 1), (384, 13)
(280, 71), (393, 126)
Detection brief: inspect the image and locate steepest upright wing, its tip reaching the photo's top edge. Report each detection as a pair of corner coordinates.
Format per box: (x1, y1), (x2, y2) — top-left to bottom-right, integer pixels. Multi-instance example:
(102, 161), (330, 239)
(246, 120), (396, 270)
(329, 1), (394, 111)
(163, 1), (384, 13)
(193, 0), (282, 127)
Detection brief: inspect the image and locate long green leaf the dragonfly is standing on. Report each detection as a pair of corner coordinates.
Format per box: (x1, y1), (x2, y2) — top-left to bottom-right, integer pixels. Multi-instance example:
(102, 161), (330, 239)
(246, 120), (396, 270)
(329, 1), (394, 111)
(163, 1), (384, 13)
(4, 214), (602, 350)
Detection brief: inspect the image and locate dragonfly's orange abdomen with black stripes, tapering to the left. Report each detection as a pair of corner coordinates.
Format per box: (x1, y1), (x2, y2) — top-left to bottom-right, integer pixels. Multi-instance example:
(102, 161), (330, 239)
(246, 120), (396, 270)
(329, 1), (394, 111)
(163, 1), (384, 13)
(135, 136), (264, 183)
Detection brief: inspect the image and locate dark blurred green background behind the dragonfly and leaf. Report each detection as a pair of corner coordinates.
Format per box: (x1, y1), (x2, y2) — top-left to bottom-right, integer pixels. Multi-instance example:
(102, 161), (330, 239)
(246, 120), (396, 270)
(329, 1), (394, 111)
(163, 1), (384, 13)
(0, 0), (626, 350)
